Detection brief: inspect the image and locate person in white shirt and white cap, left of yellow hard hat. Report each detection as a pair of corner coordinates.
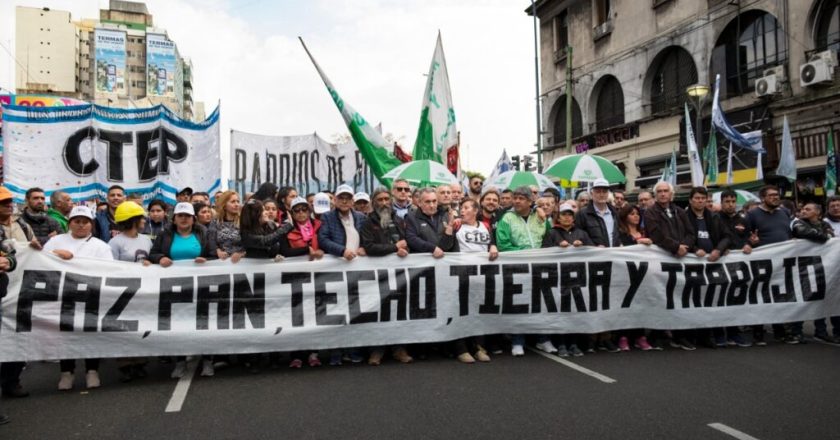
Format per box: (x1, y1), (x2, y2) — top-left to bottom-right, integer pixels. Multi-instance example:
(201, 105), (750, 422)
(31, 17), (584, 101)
(44, 206), (114, 390)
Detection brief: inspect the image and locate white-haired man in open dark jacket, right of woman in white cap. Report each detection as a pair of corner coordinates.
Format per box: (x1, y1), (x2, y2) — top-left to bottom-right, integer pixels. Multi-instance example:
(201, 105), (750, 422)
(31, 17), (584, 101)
(575, 179), (621, 247)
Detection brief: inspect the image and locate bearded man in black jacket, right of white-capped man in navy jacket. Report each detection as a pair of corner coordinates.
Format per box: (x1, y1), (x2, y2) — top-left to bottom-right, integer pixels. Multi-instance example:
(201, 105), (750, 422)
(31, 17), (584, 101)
(360, 188), (408, 257)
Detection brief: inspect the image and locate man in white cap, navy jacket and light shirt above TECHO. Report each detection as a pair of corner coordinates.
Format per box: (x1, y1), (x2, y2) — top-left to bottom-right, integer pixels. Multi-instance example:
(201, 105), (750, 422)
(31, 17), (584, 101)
(318, 185), (365, 260)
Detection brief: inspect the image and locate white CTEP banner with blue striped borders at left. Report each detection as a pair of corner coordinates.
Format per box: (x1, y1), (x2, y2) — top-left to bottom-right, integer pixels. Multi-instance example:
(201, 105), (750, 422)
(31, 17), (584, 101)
(3, 104), (221, 203)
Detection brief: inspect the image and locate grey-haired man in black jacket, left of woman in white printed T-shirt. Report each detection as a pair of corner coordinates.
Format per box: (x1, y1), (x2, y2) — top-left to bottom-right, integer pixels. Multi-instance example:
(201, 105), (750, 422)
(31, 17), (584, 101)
(405, 188), (458, 258)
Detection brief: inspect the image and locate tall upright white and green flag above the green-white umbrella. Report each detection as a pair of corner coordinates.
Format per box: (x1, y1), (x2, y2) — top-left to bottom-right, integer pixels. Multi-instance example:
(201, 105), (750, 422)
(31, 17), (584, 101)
(412, 33), (458, 171)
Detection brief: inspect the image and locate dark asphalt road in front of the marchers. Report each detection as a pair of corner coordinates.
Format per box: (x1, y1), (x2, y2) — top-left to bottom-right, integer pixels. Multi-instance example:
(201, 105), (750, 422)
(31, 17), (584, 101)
(0, 336), (840, 440)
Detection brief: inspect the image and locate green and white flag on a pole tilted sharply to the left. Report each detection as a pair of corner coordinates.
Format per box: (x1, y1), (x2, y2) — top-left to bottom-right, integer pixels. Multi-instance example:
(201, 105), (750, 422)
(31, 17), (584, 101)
(300, 38), (402, 186)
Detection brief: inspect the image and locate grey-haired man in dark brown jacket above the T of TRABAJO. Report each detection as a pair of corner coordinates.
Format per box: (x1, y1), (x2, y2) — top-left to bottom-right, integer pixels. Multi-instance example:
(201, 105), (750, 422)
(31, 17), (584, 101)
(645, 182), (696, 350)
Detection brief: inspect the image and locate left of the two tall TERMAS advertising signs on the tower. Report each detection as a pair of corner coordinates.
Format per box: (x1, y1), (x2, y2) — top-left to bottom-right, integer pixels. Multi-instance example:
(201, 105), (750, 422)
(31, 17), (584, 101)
(94, 29), (126, 95)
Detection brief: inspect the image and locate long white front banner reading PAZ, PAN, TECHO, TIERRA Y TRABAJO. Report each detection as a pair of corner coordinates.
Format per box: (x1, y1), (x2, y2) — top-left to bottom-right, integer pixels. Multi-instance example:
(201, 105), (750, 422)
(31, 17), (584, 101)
(0, 239), (840, 361)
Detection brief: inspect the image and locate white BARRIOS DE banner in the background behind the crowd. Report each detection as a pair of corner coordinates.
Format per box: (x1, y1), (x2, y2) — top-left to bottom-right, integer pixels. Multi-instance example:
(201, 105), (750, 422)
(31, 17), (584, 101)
(229, 130), (379, 194)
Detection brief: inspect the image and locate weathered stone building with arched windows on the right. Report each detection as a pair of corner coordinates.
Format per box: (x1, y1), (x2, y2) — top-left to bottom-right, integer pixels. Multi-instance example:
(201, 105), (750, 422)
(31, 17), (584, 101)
(525, 0), (840, 194)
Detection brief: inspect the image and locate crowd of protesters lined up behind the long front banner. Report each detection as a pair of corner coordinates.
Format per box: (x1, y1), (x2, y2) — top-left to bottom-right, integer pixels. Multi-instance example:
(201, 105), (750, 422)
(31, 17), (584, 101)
(0, 176), (840, 422)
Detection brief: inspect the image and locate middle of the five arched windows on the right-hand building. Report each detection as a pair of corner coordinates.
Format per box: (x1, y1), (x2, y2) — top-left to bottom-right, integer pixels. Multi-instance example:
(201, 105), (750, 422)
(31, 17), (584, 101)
(650, 47), (697, 114)
